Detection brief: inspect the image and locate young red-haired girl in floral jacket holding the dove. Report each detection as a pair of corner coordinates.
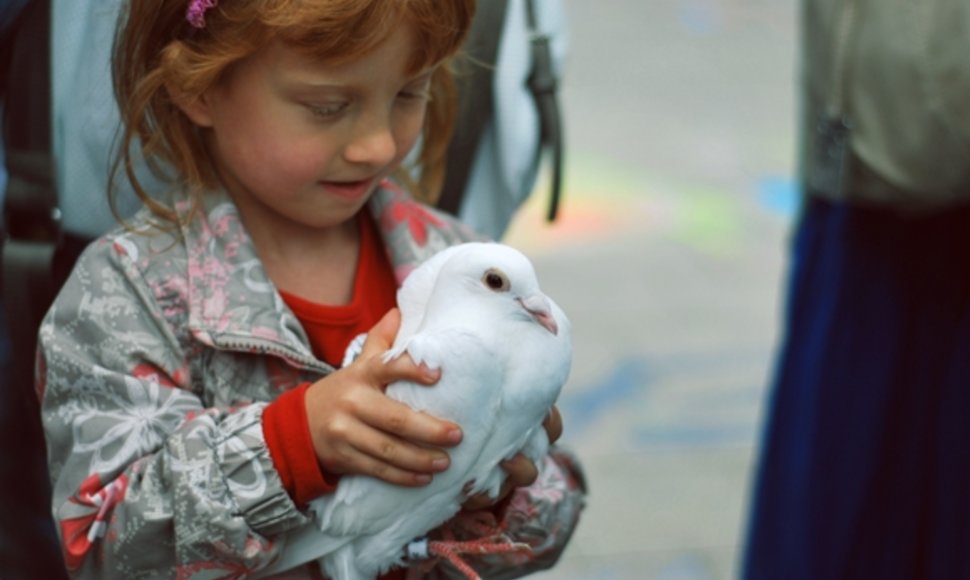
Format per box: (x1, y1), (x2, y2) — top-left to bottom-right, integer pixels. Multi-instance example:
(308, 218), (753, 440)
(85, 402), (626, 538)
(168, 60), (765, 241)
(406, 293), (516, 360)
(38, 0), (582, 578)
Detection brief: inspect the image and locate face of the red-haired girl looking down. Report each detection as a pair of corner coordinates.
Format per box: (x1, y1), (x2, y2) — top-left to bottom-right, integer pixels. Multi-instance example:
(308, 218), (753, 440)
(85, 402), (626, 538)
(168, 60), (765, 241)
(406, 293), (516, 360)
(183, 27), (432, 231)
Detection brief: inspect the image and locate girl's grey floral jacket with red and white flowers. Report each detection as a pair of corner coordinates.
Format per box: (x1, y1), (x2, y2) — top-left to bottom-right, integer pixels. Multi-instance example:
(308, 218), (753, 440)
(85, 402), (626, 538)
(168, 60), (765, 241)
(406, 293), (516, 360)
(37, 185), (583, 578)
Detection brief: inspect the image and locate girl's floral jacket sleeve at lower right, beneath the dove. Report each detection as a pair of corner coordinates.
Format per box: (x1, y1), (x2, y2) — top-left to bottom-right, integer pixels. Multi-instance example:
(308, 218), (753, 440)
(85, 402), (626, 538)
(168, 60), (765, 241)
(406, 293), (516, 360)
(416, 447), (586, 579)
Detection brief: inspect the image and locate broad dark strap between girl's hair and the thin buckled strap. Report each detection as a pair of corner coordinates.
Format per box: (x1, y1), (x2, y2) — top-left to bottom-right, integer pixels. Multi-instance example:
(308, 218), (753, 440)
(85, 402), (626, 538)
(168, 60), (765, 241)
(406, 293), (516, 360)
(438, 0), (508, 215)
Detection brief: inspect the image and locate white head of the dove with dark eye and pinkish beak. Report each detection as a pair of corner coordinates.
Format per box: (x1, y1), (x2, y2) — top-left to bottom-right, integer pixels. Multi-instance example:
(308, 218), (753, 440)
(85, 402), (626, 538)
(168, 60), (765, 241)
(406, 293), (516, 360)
(439, 243), (569, 335)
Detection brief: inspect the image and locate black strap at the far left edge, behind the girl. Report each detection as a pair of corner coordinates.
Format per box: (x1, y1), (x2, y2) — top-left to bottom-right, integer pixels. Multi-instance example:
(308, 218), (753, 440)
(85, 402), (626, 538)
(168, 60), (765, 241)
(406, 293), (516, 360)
(3, 0), (59, 393)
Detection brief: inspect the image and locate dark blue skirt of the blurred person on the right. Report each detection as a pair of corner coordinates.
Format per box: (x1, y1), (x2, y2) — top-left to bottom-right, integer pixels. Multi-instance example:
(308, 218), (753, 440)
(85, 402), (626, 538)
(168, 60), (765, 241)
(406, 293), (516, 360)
(743, 200), (970, 580)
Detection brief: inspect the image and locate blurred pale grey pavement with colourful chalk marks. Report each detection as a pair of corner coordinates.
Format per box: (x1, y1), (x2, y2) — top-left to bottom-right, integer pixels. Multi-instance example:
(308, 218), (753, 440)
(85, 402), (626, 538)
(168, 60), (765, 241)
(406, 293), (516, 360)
(505, 0), (798, 580)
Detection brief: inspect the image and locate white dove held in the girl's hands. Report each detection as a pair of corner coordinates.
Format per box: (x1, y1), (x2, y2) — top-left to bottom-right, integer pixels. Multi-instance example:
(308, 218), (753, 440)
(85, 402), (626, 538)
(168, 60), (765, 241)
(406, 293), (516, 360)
(263, 242), (572, 580)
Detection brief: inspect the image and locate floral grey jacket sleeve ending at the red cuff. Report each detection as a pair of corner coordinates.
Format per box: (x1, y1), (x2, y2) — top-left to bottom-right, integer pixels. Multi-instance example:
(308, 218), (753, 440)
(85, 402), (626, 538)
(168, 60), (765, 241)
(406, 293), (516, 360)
(37, 241), (306, 578)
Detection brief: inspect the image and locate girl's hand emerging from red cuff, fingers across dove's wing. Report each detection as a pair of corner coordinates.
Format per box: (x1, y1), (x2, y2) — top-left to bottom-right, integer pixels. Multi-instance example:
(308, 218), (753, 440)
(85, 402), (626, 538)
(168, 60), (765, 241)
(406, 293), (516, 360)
(306, 309), (461, 487)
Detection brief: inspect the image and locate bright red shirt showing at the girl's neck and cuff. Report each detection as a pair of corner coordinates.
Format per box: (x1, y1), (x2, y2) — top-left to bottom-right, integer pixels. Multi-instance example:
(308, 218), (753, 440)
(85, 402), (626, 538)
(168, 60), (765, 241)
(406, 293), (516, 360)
(263, 212), (397, 506)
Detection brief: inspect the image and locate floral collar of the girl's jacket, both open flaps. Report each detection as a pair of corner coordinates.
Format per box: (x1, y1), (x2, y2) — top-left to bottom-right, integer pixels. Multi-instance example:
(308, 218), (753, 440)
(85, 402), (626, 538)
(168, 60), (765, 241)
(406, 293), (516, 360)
(174, 182), (480, 366)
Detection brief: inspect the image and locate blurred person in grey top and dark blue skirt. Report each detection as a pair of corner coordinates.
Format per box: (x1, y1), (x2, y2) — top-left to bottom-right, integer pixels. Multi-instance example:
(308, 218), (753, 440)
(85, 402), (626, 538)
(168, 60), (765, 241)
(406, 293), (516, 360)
(742, 0), (970, 580)
